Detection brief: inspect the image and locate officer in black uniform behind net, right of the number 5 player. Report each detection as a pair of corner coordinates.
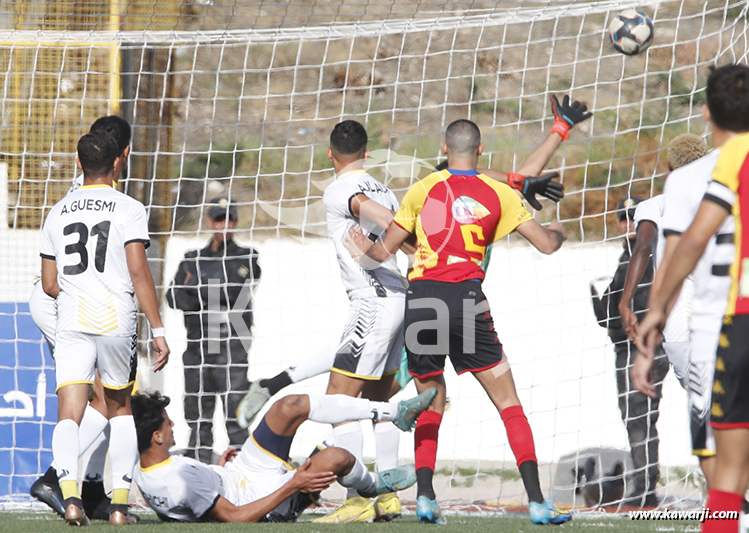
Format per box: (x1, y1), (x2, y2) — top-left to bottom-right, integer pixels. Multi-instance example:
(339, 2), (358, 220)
(590, 196), (668, 507)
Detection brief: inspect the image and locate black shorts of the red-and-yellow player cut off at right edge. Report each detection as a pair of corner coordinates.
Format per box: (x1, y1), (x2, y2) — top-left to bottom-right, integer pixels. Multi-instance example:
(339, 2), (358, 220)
(710, 315), (749, 429)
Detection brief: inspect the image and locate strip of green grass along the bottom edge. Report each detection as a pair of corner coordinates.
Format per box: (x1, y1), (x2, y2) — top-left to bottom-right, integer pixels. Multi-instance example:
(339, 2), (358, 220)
(0, 513), (700, 533)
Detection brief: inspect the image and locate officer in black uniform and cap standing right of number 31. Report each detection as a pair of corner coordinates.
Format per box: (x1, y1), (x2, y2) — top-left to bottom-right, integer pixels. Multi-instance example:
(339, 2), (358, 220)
(166, 198), (260, 463)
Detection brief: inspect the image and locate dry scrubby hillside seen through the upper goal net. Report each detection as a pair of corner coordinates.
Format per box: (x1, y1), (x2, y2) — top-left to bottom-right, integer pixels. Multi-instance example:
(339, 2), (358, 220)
(143, 0), (745, 239)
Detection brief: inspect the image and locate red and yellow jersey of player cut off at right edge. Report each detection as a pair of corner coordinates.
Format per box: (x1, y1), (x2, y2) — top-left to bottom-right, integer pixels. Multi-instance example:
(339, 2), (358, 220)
(705, 133), (749, 316)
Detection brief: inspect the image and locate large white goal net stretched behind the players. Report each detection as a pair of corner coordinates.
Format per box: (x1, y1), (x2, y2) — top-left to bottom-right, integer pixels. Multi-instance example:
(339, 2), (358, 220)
(0, 0), (747, 512)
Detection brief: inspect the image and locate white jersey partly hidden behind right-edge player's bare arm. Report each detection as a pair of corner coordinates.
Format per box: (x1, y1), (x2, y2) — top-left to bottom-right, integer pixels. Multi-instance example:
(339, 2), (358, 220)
(661, 150), (736, 331)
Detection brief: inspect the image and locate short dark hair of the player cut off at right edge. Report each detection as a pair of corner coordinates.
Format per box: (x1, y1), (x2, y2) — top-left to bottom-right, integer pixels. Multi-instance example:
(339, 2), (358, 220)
(706, 65), (749, 133)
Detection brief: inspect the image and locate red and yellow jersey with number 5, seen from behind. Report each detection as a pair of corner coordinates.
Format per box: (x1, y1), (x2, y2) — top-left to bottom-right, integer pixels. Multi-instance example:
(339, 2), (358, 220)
(394, 170), (532, 283)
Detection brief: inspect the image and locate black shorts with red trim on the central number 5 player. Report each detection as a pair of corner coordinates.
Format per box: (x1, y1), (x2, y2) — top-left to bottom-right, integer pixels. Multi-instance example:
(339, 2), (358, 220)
(404, 280), (506, 379)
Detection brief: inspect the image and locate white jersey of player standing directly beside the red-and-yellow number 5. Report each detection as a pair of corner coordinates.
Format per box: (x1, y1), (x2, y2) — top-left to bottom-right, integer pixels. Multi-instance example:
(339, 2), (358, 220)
(323, 170), (408, 297)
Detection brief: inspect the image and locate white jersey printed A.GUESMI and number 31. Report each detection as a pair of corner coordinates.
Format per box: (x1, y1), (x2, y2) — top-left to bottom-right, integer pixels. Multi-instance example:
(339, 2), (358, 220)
(41, 185), (149, 337)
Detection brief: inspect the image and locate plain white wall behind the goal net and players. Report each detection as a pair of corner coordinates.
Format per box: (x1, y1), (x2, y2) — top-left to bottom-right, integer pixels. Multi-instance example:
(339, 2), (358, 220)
(0, 230), (694, 465)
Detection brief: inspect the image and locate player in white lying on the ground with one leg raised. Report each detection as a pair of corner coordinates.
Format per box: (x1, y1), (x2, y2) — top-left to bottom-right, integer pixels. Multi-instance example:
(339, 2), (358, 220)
(132, 389), (437, 522)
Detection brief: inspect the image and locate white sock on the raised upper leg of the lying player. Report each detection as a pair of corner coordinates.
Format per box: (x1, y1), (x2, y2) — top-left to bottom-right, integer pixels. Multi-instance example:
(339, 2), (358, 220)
(308, 394), (398, 424)
